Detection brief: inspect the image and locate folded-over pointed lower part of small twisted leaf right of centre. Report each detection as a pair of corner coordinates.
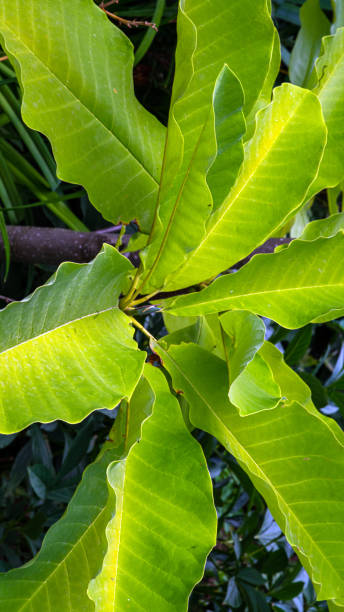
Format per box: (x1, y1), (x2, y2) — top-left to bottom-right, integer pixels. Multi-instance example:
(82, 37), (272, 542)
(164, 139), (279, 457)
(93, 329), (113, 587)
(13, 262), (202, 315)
(229, 352), (282, 416)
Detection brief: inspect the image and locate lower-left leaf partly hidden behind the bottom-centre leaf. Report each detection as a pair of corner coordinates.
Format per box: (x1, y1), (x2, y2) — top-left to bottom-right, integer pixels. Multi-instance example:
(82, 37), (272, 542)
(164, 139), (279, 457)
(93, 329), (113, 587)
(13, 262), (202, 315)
(0, 379), (154, 612)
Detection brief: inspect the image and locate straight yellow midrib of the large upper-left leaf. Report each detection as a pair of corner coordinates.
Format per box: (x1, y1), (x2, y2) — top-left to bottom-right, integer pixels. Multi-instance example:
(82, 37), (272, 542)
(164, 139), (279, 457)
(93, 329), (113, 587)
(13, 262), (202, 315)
(0, 19), (159, 187)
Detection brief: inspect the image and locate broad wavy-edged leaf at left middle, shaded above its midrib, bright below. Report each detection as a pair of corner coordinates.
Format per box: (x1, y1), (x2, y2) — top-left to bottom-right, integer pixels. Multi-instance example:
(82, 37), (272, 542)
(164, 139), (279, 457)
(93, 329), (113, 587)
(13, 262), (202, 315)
(0, 245), (145, 433)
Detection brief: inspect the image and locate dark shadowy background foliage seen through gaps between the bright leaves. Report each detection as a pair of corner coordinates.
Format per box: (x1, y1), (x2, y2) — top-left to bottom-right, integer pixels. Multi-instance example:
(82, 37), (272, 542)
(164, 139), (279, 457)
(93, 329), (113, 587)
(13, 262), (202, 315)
(0, 0), (344, 612)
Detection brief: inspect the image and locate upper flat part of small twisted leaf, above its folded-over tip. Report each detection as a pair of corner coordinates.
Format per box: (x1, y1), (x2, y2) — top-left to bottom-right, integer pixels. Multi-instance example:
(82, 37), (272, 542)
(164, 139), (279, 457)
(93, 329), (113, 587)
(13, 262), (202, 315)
(219, 310), (265, 384)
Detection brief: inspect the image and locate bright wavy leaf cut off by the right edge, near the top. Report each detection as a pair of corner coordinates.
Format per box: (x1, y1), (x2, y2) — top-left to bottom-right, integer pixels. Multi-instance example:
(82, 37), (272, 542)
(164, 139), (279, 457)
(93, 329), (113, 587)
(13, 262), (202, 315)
(307, 28), (344, 200)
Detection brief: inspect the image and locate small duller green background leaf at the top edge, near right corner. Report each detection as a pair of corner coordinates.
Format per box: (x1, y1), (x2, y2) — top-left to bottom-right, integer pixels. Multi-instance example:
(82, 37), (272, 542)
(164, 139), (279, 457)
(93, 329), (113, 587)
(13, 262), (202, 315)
(289, 0), (330, 87)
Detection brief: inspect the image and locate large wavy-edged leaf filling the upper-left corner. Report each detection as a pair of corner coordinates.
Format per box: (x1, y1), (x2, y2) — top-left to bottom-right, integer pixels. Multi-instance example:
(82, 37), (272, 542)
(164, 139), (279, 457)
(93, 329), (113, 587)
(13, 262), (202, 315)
(0, 0), (165, 230)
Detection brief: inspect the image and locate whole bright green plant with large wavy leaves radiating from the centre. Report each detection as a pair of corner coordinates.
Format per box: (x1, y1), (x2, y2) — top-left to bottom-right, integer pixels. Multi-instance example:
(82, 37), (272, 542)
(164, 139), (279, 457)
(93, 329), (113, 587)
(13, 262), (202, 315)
(0, 0), (344, 612)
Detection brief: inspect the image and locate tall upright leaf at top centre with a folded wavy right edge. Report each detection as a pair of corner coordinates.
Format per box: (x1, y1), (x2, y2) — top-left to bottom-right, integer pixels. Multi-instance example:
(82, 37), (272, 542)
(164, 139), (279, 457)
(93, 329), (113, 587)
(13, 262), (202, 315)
(141, 0), (274, 292)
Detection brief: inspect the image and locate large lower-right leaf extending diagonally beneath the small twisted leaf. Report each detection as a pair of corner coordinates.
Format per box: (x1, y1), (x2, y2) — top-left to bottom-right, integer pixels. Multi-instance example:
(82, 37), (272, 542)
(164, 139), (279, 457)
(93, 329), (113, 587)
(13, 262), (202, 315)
(155, 345), (344, 603)
